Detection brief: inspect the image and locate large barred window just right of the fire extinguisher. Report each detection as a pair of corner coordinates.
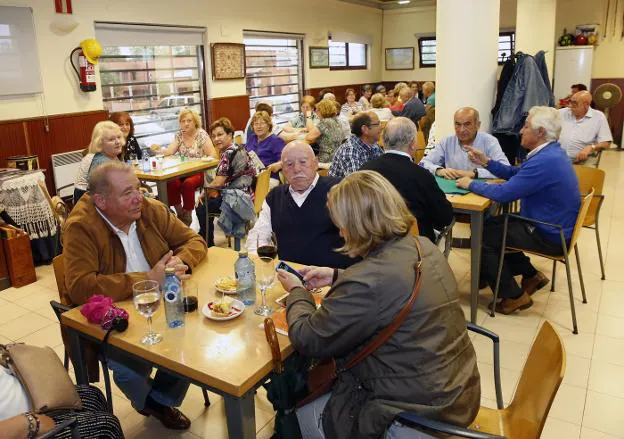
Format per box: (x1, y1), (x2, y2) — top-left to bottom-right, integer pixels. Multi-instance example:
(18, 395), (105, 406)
(96, 24), (206, 147)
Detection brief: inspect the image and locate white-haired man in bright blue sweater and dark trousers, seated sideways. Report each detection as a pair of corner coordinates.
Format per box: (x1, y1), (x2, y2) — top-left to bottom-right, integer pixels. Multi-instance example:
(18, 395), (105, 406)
(457, 107), (581, 314)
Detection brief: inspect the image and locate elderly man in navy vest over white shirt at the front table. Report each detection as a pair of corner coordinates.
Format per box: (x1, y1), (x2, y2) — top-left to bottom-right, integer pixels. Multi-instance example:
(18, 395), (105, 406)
(247, 140), (357, 268)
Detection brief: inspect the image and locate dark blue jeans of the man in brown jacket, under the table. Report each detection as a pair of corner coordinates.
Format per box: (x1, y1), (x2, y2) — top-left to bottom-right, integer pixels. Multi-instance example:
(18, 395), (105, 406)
(108, 352), (190, 410)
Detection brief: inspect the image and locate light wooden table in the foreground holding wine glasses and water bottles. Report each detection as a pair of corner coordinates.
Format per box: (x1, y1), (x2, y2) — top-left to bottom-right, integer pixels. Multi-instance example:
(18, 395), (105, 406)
(61, 247), (293, 439)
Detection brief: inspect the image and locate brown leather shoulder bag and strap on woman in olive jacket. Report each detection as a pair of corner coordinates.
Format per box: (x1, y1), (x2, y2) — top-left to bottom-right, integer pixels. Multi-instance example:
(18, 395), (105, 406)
(296, 239), (422, 408)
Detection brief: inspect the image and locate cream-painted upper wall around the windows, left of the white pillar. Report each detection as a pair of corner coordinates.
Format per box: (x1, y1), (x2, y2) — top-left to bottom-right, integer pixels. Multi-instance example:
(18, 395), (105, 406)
(0, 0), (382, 120)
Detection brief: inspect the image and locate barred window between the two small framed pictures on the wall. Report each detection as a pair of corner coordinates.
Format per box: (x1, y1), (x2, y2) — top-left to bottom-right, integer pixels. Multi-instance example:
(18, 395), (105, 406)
(244, 32), (303, 125)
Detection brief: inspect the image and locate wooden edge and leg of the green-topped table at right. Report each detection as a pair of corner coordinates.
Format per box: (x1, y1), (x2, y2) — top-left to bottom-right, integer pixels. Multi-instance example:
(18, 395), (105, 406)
(446, 192), (492, 323)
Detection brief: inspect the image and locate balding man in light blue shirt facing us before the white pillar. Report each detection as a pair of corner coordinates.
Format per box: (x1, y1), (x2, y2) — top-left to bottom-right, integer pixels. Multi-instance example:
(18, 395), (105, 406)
(420, 107), (509, 180)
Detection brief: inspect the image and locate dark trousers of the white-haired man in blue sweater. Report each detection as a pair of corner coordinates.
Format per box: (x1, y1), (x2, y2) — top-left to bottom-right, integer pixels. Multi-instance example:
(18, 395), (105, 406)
(481, 216), (562, 299)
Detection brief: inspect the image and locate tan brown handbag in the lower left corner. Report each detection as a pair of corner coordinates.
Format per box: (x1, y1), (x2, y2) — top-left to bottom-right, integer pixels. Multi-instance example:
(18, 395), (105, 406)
(0, 343), (82, 413)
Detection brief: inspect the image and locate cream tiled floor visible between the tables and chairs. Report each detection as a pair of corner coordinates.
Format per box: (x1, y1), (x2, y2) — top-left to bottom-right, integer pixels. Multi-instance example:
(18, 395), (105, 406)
(0, 152), (624, 439)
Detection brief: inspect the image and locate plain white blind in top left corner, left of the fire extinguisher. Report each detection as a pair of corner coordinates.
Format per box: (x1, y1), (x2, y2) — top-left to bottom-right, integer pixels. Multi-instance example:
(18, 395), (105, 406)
(0, 6), (41, 95)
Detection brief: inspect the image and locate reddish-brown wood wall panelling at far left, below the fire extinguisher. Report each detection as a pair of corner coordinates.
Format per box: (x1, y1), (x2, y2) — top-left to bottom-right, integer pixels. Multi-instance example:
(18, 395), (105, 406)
(0, 110), (108, 195)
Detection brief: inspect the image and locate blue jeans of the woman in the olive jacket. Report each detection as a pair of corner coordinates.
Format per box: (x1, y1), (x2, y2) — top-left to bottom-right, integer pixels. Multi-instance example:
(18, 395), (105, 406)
(297, 393), (435, 439)
